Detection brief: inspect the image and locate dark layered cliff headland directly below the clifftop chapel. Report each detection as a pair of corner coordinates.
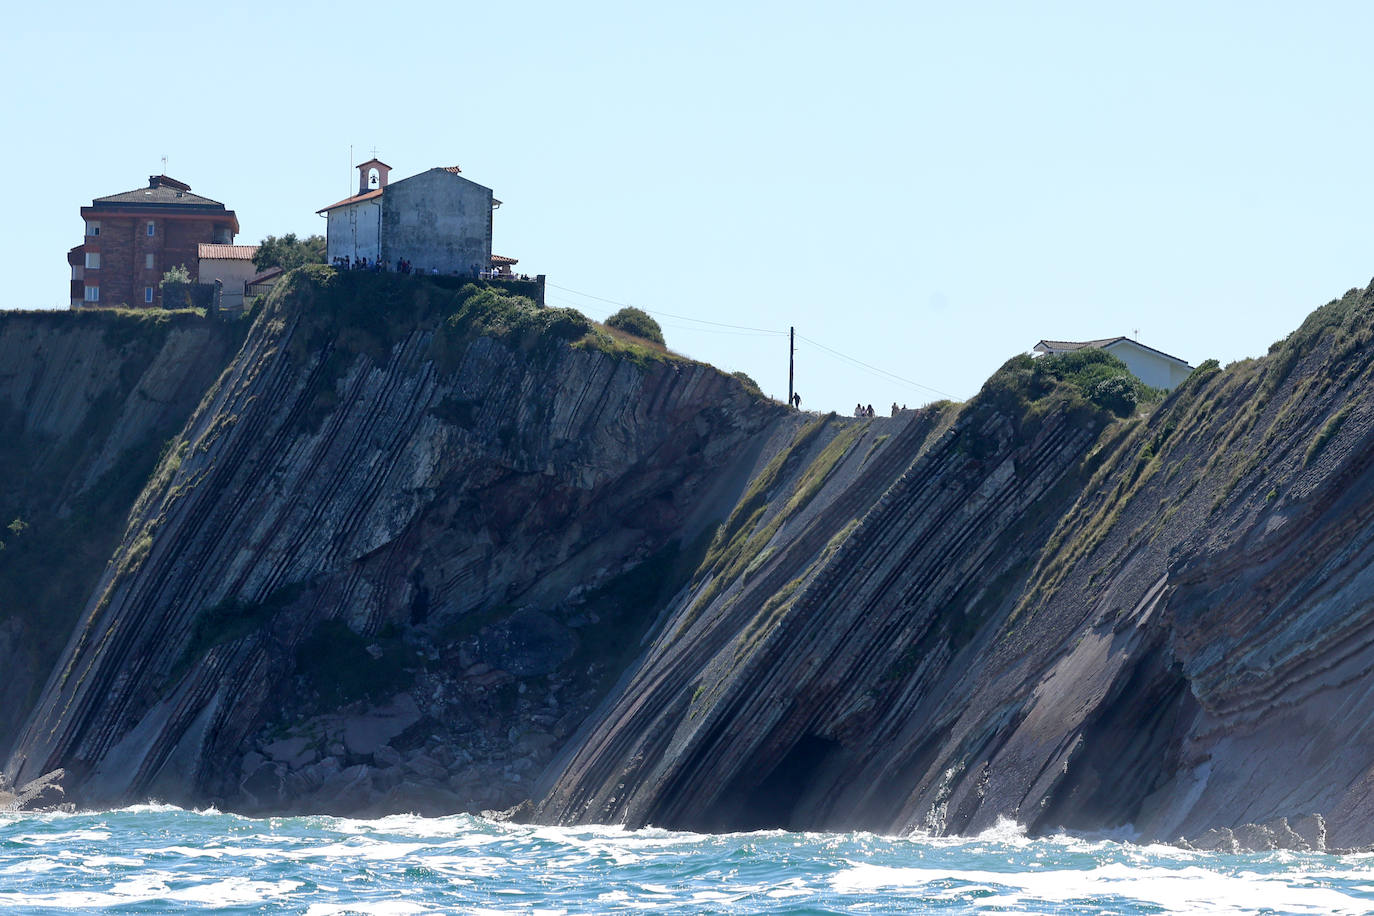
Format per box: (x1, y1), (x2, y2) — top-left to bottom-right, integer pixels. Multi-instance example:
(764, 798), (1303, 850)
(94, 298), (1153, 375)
(7, 271), (790, 810)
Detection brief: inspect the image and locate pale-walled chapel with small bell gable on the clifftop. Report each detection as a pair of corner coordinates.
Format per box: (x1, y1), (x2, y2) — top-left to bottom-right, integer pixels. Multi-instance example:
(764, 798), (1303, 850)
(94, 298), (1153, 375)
(319, 159), (500, 276)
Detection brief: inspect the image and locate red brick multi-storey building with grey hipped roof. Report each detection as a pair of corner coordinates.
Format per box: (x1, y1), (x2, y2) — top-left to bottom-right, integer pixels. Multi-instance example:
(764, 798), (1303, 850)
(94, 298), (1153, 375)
(67, 174), (239, 308)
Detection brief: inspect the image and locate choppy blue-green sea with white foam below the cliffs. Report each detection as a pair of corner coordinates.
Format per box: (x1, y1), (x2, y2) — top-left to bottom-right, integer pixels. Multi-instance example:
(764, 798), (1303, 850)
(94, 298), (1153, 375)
(0, 806), (1374, 916)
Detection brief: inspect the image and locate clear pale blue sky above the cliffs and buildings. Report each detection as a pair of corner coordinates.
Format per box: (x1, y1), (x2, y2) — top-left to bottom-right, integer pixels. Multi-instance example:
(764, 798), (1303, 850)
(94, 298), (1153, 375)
(0, 0), (1374, 413)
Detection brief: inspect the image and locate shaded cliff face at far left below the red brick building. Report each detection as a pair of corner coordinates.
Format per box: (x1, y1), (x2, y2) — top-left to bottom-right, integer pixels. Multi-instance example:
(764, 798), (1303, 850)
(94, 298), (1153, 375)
(0, 310), (242, 751)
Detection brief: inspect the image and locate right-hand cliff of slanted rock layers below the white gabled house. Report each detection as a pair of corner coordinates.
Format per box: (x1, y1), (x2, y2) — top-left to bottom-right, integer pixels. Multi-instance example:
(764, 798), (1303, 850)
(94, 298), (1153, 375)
(537, 282), (1374, 846)
